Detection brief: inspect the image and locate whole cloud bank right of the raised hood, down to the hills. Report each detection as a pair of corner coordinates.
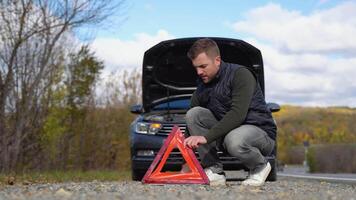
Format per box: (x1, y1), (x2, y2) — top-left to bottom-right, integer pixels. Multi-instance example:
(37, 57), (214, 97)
(232, 2), (356, 107)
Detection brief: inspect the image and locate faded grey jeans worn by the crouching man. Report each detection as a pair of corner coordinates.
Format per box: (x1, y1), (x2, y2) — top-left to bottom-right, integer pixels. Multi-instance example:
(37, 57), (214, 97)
(186, 106), (275, 173)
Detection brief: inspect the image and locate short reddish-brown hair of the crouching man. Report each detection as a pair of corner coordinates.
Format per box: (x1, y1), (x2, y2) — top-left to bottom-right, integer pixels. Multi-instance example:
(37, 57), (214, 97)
(187, 38), (220, 60)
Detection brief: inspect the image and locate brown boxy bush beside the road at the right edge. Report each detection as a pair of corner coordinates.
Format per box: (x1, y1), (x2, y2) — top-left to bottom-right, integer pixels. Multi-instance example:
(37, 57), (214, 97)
(307, 144), (356, 173)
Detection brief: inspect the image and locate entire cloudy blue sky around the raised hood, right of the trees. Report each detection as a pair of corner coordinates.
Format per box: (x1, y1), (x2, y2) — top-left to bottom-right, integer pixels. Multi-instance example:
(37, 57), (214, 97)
(91, 0), (356, 107)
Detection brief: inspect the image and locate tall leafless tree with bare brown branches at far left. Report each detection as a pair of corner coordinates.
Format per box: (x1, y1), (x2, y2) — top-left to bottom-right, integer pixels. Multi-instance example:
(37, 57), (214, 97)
(0, 0), (123, 171)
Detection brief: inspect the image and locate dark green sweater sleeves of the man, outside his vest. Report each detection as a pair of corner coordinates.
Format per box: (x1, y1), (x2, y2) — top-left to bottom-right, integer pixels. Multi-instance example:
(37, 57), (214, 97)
(191, 67), (256, 143)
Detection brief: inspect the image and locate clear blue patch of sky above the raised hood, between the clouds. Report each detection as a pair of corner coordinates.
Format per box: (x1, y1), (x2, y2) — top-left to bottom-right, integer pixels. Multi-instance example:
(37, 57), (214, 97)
(98, 0), (341, 40)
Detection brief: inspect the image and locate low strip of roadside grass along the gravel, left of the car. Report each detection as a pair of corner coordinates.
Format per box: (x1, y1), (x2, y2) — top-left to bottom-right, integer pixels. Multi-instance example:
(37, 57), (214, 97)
(0, 170), (131, 185)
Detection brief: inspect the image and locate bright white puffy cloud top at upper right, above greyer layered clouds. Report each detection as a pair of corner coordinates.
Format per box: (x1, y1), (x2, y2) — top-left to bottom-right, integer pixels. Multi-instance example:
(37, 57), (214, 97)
(233, 2), (356, 54)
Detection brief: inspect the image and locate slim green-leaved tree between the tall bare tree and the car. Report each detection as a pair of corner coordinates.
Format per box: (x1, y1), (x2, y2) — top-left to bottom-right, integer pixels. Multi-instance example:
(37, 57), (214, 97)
(61, 46), (104, 169)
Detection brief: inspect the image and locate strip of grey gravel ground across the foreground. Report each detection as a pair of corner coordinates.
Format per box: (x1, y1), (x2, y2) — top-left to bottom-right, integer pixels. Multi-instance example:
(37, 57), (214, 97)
(0, 173), (356, 200)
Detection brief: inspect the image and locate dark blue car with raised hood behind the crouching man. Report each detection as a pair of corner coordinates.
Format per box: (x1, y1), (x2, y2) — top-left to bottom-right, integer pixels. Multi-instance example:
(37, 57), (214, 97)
(129, 37), (280, 181)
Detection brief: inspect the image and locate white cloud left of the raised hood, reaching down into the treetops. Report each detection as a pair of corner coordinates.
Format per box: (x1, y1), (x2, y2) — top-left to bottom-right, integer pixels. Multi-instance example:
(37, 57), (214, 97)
(91, 30), (174, 100)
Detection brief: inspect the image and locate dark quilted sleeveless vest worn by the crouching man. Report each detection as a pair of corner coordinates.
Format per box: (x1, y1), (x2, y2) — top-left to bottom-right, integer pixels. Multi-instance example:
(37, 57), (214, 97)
(196, 62), (277, 140)
